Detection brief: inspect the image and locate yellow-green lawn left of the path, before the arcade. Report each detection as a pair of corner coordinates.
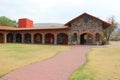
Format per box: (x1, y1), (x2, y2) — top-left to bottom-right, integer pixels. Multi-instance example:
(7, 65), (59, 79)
(0, 44), (71, 77)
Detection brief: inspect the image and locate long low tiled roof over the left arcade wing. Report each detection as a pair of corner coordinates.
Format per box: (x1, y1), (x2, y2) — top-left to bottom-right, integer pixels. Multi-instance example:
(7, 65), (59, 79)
(0, 26), (69, 30)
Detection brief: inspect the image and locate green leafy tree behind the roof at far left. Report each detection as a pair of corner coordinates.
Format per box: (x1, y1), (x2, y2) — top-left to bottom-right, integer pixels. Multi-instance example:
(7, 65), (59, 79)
(0, 16), (17, 27)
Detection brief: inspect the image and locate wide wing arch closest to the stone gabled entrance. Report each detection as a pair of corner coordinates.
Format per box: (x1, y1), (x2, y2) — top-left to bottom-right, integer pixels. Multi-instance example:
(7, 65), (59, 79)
(57, 33), (68, 44)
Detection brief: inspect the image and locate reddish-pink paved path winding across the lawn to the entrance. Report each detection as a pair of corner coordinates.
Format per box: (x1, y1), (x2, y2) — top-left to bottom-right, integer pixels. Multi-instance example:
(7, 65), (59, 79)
(0, 46), (90, 80)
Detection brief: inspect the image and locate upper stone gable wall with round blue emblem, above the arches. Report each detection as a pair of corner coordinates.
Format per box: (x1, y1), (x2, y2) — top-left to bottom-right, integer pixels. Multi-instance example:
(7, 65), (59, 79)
(71, 16), (102, 32)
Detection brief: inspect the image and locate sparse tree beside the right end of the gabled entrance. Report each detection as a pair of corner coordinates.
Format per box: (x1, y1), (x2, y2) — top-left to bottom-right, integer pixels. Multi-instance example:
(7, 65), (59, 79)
(103, 17), (117, 42)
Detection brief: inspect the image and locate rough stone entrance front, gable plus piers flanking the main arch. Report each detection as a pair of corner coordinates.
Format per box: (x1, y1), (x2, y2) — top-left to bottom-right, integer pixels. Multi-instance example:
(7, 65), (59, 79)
(70, 15), (103, 44)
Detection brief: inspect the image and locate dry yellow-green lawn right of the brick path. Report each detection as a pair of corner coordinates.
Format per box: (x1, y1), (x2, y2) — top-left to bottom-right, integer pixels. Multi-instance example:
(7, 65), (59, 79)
(70, 42), (120, 80)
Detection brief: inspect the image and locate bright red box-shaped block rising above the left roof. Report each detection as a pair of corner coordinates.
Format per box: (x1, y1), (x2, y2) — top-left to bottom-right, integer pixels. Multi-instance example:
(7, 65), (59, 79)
(18, 18), (33, 28)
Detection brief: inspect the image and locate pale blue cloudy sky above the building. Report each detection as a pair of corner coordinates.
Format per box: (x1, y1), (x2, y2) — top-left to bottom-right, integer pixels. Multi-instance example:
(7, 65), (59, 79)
(0, 0), (120, 23)
